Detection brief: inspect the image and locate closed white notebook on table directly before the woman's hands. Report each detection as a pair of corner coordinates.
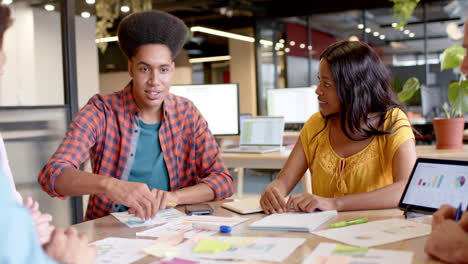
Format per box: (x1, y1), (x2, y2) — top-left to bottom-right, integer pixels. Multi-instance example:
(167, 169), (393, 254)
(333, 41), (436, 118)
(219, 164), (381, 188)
(249, 210), (337, 232)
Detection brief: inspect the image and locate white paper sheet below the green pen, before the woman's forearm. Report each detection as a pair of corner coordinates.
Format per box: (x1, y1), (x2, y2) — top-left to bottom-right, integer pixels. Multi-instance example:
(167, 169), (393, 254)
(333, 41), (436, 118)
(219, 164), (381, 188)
(312, 218), (431, 247)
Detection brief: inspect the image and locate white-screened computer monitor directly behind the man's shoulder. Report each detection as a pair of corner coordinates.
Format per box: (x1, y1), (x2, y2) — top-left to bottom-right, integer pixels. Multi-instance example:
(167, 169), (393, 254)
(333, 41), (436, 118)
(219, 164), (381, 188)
(170, 83), (239, 136)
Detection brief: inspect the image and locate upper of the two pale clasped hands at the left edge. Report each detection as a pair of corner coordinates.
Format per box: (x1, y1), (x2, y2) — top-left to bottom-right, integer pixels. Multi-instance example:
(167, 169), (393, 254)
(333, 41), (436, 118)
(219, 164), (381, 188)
(24, 197), (54, 245)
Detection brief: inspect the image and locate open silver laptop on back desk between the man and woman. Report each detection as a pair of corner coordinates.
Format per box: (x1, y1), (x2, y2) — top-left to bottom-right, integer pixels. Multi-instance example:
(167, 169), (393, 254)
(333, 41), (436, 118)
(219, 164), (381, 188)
(223, 116), (284, 153)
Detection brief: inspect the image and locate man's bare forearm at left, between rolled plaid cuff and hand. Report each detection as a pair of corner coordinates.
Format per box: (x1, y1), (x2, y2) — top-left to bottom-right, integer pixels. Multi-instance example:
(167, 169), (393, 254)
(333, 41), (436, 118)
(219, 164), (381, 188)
(55, 168), (110, 196)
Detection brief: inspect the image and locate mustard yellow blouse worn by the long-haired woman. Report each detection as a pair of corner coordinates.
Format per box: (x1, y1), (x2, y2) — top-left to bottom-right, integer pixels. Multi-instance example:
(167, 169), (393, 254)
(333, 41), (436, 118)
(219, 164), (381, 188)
(300, 108), (414, 197)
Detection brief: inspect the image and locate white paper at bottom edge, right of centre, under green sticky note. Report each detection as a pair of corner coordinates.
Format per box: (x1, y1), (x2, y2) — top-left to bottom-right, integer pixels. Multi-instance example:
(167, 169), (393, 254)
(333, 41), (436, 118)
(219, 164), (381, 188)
(303, 243), (413, 264)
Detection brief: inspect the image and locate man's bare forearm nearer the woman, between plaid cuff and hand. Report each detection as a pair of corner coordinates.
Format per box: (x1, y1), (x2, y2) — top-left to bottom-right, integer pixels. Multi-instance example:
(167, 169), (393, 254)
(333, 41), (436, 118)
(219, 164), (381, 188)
(173, 183), (215, 204)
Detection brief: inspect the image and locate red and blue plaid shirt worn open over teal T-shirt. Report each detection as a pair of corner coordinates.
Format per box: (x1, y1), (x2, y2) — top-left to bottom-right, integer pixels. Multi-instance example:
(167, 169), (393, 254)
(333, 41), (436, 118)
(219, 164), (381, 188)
(38, 83), (234, 220)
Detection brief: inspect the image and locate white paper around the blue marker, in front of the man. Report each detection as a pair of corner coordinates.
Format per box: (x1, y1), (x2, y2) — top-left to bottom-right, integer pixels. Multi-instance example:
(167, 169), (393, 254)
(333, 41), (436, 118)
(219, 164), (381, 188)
(136, 215), (249, 238)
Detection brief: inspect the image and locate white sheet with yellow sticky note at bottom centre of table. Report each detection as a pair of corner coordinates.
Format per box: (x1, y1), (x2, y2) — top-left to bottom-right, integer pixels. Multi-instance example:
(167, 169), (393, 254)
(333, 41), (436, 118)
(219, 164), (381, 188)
(177, 236), (305, 262)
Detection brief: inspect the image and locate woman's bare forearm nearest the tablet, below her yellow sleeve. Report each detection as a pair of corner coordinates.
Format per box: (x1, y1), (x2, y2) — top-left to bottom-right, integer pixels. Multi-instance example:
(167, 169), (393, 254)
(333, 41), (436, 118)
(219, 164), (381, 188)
(336, 181), (406, 211)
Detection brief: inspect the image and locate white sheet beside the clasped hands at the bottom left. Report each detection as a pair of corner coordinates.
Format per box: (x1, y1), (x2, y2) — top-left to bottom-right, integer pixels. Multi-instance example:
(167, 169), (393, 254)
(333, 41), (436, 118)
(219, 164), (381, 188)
(90, 237), (153, 264)
